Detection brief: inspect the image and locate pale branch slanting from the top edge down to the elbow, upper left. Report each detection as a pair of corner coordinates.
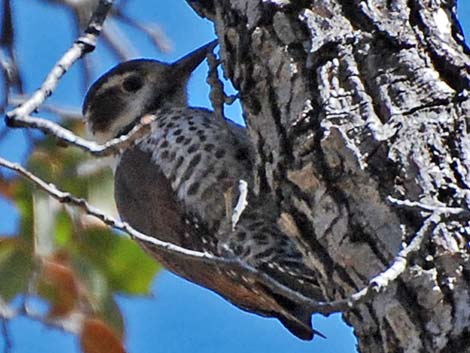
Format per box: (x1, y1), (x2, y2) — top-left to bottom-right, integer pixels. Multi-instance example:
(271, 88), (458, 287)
(5, 0), (113, 127)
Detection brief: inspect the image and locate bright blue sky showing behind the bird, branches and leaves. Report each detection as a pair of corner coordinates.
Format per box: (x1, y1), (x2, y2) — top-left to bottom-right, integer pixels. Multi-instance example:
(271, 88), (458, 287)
(0, 0), (470, 353)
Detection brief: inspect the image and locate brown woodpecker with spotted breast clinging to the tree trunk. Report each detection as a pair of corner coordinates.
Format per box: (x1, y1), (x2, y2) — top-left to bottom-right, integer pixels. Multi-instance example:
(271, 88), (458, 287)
(83, 41), (324, 340)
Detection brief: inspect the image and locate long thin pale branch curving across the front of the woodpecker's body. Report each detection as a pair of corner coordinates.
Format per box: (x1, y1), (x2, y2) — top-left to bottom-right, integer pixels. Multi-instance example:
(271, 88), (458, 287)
(0, 157), (450, 315)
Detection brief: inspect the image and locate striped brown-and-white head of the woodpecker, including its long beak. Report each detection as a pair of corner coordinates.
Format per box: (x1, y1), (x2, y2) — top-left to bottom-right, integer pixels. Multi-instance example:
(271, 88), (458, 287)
(83, 41), (217, 143)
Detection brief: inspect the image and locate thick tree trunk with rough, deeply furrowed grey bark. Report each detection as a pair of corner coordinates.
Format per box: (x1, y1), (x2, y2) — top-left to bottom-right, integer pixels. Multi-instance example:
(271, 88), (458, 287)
(189, 0), (470, 353)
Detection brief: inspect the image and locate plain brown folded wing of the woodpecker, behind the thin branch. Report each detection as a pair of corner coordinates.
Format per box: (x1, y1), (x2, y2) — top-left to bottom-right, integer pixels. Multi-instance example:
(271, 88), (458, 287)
(115, 147), (320, 339)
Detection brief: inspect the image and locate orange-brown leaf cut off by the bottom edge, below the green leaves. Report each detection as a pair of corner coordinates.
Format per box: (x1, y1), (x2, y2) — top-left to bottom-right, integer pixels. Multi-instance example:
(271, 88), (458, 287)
(80, 319), (126, 353)
